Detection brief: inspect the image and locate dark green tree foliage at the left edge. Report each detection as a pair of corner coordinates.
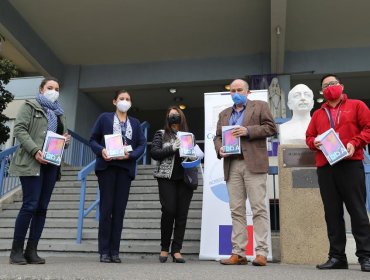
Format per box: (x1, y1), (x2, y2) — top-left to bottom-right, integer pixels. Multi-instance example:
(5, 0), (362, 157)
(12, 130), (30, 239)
(0, 58), (17, 145)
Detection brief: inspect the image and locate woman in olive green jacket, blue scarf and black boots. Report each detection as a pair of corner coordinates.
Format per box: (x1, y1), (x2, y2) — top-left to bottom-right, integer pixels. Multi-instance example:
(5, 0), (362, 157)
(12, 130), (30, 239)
(9, 78), (70, 264)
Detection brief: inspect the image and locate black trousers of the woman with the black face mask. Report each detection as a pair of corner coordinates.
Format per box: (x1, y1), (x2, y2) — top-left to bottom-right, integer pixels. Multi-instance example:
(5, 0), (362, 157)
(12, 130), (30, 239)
(158, 179), (193, 253)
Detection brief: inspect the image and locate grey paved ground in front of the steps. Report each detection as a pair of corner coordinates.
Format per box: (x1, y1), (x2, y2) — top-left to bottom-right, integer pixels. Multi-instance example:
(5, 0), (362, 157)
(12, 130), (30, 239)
(0, 254), (370, 280)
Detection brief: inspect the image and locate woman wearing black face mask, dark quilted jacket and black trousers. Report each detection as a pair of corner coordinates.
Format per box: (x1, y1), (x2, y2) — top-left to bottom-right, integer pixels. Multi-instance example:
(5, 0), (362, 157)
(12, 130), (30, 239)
(151, 106), (193, 263)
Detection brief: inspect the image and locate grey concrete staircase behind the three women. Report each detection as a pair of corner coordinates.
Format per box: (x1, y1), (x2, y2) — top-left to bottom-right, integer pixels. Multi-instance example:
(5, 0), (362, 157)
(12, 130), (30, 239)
(0, 166), (203, 256)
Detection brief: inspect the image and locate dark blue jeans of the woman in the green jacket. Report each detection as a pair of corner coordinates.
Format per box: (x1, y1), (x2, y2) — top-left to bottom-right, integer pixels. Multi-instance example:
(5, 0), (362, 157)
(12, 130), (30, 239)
(14, 164), (58, 242)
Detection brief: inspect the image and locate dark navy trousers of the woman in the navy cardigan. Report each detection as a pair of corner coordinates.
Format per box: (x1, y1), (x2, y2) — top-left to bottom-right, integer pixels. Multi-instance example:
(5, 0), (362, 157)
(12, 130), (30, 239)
(96, 166), (131, 256)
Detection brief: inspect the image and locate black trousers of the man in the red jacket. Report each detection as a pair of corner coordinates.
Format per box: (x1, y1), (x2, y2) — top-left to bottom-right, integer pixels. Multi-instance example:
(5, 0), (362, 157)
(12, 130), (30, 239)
(317, 160), (370, 261)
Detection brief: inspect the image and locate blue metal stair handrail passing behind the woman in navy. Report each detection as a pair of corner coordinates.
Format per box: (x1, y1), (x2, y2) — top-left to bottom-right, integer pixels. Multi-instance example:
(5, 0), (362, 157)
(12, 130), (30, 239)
(76, 122), (150, 244)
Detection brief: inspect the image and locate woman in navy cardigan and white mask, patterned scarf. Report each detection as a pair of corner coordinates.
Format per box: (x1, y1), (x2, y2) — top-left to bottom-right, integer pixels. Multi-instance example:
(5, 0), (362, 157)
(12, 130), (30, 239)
(90, 89), (146, 263)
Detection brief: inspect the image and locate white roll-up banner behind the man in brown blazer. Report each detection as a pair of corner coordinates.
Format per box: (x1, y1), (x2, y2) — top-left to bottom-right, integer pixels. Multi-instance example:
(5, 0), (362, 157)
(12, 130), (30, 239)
(199, 90), (272, 260)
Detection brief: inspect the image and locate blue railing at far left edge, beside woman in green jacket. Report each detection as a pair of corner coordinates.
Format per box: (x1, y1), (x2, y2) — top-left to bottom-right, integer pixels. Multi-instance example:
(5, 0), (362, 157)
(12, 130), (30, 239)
(0, 145), (20, 198)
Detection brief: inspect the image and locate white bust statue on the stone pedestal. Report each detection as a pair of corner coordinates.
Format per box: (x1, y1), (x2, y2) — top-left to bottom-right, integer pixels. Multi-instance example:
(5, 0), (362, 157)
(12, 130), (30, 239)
(279, 84), (314, 144)
